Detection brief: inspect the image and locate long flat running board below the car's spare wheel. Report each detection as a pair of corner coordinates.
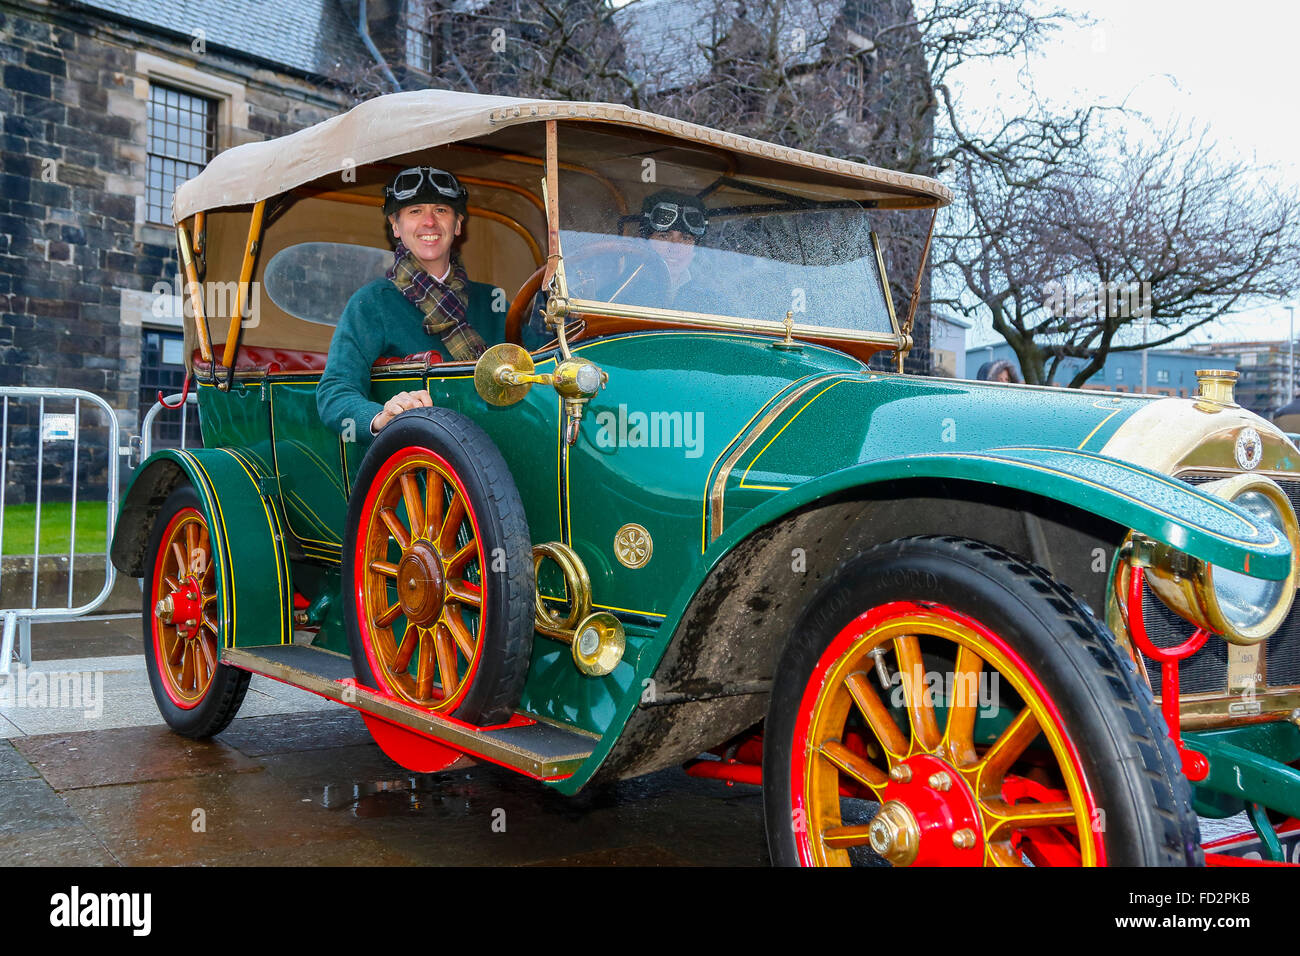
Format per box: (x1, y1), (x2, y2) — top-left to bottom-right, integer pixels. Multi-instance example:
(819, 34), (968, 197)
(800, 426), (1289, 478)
(221, 644), (597, 780)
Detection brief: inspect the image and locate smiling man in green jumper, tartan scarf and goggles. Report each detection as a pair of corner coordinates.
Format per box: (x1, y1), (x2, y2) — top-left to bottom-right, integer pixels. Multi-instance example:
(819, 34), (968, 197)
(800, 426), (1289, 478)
(316, 166), (506, 441)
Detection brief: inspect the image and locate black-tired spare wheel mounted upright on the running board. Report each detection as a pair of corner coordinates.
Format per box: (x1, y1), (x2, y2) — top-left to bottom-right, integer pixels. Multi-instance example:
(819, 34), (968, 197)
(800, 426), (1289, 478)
(343, 408), (534, 726)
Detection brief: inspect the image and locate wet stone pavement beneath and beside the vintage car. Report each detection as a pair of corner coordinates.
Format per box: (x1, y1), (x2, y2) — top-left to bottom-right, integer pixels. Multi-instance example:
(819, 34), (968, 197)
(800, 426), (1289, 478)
(0, 618), (767, 866)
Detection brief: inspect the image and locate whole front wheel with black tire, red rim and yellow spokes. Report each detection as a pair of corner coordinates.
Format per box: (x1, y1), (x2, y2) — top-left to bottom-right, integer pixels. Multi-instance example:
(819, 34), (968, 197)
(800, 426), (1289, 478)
(763, 538), (1200, 866)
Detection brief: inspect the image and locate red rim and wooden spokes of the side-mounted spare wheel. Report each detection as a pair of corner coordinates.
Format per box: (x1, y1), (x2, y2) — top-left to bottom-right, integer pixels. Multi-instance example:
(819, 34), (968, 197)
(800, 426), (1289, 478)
(352, 446), (488, 711)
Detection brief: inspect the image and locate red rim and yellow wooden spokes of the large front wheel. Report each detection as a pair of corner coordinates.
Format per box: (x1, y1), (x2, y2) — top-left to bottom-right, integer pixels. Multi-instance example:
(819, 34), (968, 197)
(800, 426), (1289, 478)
(790, 602), (1105, 866)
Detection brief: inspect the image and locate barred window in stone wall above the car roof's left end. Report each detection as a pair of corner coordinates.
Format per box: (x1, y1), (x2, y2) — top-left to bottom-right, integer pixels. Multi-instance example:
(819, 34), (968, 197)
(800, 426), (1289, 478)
(144, 83), (217, 226)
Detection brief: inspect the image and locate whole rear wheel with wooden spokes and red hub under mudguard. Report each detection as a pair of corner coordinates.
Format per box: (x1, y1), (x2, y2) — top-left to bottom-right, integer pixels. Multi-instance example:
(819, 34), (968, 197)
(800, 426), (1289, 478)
(143, 485), (248, 736)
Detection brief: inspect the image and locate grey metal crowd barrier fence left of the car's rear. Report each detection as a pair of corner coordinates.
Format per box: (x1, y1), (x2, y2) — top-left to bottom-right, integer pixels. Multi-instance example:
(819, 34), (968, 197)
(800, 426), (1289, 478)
(0, 386), (198, 674)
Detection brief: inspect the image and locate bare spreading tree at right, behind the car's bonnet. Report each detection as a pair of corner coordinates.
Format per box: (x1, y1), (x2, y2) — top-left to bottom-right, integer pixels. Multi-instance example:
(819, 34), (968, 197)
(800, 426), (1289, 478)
(936, 117), (1300, 386)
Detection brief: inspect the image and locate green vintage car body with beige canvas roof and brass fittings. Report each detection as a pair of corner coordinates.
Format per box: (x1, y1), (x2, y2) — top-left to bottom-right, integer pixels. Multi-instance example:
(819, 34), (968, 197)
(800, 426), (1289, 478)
(112, 92), (1300, 856)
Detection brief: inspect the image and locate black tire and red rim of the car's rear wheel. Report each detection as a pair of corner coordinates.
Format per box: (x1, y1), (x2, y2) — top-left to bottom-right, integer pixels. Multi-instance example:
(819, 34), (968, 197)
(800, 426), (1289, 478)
(142, 485), (251, 739)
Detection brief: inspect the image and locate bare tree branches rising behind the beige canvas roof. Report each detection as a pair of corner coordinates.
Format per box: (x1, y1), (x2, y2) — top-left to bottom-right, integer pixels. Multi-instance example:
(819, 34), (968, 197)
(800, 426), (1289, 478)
(358, 0), (1118, 371)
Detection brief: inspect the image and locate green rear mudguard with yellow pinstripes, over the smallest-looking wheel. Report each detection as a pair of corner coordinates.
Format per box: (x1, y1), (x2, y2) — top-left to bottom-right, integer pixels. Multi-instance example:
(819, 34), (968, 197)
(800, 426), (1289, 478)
(111, 449), (294, 648)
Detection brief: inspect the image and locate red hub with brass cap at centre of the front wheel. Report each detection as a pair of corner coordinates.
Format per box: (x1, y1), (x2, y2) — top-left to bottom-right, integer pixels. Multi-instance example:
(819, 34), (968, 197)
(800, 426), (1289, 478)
(870, 754), (984, 866)
